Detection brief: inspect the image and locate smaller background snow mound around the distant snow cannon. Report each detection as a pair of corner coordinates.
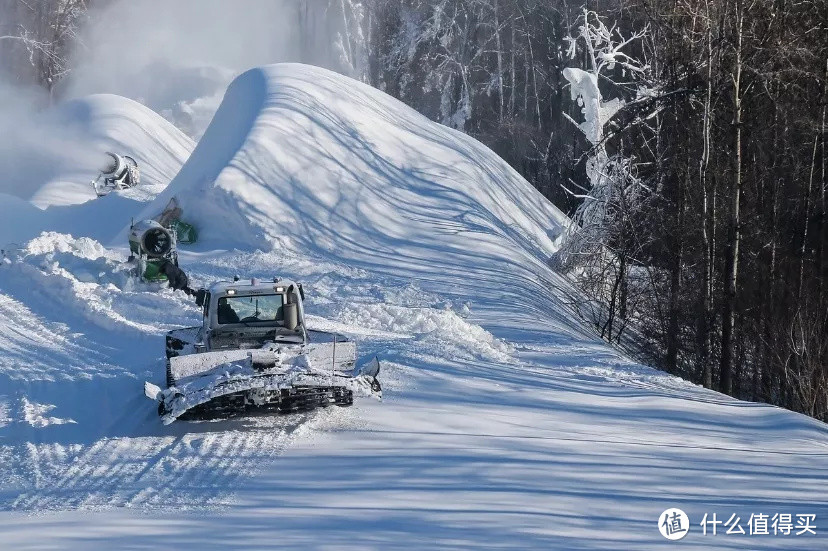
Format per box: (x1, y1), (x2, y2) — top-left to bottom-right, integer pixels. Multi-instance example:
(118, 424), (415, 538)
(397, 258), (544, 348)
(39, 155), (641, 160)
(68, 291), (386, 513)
(0, 94), (195, 245)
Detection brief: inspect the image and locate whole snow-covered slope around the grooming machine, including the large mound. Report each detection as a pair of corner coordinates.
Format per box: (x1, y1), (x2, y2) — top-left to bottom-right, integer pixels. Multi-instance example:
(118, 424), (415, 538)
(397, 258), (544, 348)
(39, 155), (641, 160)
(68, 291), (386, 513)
(0, 64), (828, 550)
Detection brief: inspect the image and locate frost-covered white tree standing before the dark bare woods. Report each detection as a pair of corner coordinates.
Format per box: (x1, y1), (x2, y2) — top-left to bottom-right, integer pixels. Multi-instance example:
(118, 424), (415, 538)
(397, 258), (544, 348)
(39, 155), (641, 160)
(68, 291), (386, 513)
(555, 9), (653, 339)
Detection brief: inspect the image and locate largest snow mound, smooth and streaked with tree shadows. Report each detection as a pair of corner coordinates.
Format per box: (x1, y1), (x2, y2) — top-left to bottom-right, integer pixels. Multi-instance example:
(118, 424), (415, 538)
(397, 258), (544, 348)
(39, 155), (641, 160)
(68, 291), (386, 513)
(133, 64), (567, 310)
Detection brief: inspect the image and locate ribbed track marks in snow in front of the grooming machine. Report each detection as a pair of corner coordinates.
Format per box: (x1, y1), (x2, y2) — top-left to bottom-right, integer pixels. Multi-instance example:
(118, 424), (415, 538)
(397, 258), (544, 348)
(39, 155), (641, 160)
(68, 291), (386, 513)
(7, 414), (312, 511)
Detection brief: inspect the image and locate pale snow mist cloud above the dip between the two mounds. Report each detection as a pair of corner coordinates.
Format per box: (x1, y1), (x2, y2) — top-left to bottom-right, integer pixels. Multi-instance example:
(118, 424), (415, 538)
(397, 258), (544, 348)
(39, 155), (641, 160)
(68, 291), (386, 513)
(63, 0), (338, 139)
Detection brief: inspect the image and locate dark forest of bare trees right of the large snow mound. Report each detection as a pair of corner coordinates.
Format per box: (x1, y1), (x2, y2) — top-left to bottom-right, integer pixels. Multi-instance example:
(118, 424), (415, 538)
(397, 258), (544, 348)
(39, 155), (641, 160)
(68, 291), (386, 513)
(342, 0), (828, 420)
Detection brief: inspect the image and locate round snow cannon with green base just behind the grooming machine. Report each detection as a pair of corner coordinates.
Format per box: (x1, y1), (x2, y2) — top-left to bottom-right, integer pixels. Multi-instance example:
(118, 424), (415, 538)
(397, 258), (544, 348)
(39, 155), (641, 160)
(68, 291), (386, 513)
(129, 220), (178, 282)
